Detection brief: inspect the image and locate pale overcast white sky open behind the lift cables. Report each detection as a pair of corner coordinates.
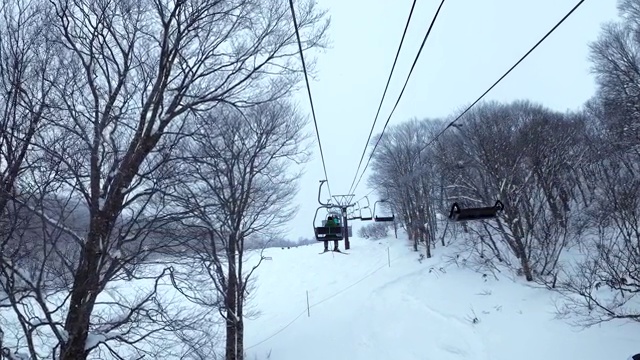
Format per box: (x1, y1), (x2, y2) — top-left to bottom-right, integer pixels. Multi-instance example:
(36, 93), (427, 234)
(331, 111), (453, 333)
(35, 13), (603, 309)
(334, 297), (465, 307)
(289, 0), (617, 240)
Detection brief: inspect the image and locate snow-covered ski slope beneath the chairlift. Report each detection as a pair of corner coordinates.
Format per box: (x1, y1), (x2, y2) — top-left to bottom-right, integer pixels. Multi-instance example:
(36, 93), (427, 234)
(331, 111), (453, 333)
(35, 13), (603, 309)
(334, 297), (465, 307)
(245, 239), (640, 360)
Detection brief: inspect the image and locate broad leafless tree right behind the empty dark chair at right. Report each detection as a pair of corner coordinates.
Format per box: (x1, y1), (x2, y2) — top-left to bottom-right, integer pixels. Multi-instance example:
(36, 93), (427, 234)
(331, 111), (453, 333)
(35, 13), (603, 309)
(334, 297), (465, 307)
(442, 102), (585, 281)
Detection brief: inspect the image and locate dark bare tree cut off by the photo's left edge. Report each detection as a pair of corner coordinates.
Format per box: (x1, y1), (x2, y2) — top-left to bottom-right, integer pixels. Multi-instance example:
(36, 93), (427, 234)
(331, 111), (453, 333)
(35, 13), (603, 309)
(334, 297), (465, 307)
(0, 0), (58, 358)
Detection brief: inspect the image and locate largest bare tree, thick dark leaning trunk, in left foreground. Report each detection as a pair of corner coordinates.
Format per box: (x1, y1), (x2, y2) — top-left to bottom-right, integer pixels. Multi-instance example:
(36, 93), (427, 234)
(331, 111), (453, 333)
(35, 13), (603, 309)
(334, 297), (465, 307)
(0, 0), (327, 360)
